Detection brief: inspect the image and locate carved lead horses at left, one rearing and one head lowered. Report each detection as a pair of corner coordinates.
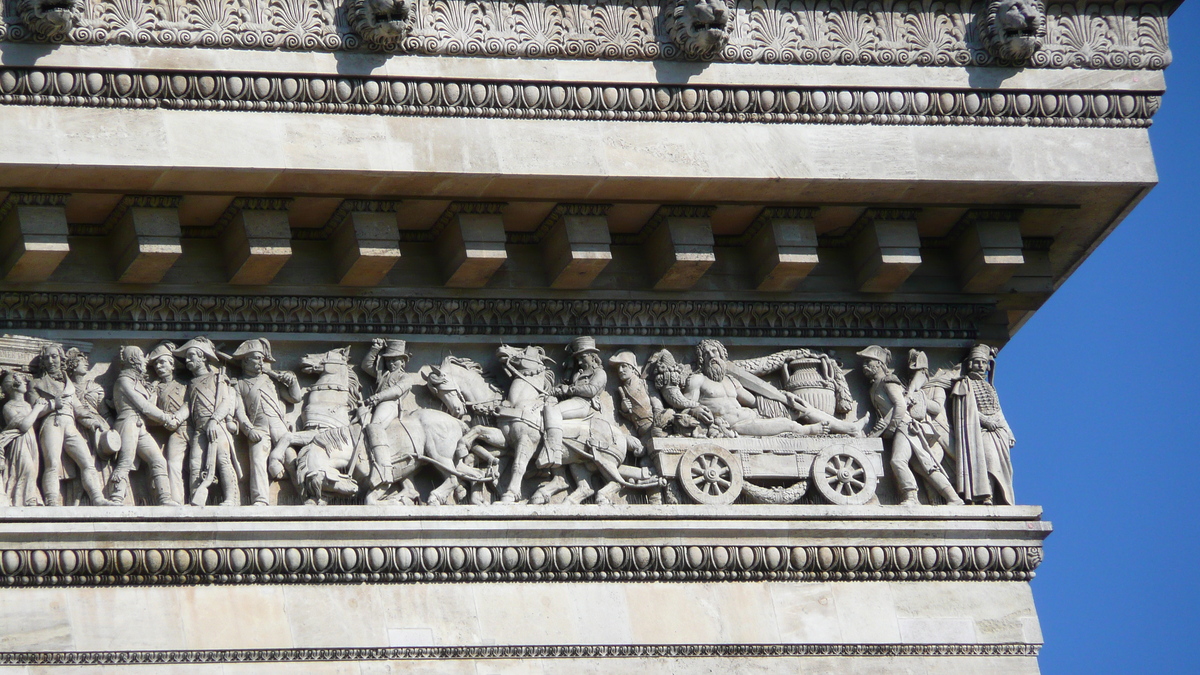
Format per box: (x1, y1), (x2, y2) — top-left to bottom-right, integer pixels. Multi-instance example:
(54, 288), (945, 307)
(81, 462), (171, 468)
(280, 347), (497, 504)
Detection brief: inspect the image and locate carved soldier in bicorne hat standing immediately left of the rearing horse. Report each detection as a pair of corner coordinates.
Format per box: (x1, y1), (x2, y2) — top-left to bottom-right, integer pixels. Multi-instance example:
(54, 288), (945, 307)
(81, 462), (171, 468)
(233, 338), (304, 506)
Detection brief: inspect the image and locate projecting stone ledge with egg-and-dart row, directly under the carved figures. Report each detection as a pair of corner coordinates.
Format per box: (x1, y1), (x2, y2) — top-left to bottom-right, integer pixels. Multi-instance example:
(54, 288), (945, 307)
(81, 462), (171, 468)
(0, 506), (1050, 586)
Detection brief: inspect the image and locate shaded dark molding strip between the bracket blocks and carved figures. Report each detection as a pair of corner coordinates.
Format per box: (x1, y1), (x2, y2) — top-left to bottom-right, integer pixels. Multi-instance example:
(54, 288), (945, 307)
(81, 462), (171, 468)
(0, 292), (995, 341)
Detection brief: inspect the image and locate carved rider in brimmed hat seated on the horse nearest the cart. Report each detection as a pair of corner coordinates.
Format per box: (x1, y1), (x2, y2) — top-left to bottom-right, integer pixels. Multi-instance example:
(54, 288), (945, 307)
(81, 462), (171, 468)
(540, 335), (608, 466)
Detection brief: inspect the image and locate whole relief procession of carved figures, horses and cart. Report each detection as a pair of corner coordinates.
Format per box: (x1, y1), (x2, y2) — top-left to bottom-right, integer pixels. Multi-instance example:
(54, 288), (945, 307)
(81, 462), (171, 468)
(0, 336), (1014, 508)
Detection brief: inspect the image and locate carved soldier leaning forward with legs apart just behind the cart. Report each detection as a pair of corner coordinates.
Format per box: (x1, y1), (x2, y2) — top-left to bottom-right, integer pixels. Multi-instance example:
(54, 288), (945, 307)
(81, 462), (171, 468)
(858, 345), (962, 506)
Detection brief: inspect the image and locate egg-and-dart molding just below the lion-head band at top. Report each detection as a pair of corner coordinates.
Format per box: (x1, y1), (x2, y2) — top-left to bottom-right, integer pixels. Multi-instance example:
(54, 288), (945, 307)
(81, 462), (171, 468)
(0, 67), (1162, 129)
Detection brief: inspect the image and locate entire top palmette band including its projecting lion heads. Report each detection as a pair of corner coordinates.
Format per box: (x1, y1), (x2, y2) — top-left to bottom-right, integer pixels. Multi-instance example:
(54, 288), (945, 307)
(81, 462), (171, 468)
(0, 0), (1170, 70)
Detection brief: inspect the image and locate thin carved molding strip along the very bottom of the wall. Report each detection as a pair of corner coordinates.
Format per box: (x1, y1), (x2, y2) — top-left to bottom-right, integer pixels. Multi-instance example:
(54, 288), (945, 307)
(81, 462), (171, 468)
(0, 643), (1042, 665)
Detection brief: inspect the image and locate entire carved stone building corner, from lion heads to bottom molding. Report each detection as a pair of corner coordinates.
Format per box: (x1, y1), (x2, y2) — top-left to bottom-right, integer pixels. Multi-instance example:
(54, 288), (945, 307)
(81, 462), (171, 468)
(0, 0), (1176, 675)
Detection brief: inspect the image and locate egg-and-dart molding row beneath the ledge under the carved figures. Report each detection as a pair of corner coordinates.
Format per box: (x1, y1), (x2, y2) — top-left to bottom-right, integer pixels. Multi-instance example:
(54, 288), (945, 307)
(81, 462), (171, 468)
(0, 544), (1043, 587)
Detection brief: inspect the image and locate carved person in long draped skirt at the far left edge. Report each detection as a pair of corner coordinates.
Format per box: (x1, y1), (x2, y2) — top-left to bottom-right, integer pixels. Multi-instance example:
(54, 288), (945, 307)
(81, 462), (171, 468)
(0, 370), (49, 506)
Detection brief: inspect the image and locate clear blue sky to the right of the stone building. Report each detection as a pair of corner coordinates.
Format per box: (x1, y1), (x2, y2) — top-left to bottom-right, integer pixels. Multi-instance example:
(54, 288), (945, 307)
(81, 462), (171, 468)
(996, 0), (1200, 674)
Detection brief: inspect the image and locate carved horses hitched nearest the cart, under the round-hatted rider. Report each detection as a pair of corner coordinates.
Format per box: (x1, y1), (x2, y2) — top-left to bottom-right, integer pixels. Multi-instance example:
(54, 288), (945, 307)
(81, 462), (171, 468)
(426, 346), (661, 504)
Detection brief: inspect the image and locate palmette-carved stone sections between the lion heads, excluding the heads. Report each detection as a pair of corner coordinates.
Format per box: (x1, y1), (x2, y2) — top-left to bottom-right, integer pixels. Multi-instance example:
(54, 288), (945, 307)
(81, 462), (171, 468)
(0, 0), (1174, 70)
